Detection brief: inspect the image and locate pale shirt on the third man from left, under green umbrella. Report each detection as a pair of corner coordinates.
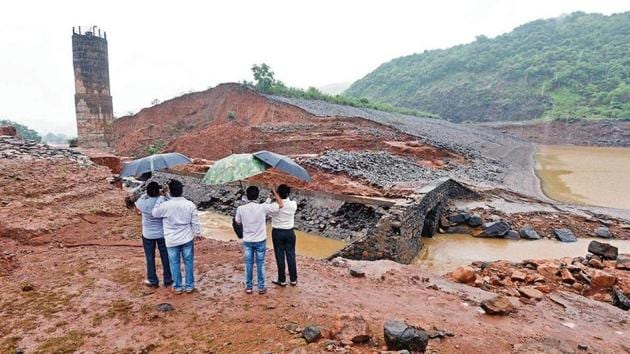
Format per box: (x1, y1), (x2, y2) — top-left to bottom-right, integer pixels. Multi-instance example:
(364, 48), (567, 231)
(235, 202), (279, 242)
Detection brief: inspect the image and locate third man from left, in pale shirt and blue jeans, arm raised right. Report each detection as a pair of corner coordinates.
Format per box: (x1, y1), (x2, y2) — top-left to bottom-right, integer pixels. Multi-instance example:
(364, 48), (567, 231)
(234, 186), (284, 295)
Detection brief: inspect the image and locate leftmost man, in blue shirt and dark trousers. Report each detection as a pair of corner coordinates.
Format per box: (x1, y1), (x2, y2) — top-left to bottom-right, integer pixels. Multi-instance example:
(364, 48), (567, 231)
(136, 182), (173, 288)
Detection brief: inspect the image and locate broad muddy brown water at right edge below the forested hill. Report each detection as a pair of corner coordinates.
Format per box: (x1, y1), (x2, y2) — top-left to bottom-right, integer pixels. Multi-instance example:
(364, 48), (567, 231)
(536, 145), (630, 209)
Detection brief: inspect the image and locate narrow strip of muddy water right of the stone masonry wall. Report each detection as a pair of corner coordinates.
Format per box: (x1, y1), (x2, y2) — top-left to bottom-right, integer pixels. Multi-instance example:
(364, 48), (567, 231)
(413, 234), (630, 274)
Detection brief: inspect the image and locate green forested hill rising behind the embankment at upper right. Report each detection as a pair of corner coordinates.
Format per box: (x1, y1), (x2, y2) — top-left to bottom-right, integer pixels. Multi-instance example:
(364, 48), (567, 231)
(345, 12), (630, 122)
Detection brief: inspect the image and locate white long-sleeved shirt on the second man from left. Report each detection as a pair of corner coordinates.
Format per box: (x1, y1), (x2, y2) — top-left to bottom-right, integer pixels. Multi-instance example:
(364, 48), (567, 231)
(151, 197), (201, 247)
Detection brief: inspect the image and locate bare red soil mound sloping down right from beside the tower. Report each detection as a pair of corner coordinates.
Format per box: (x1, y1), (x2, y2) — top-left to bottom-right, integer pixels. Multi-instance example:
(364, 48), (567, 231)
(114, 84), (456, 166)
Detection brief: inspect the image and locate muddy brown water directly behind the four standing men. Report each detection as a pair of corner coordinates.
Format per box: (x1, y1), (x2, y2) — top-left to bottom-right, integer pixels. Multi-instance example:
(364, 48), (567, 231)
(199, 211), (346, 259)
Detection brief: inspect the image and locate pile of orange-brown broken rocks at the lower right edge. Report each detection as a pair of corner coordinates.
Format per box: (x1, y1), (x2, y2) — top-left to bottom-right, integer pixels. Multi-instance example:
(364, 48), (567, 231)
(449, 241), (630, 310)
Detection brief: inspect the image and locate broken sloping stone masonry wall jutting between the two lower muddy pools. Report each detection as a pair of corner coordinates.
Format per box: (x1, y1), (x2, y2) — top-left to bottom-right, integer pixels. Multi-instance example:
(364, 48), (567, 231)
(331, 179), (475, 263)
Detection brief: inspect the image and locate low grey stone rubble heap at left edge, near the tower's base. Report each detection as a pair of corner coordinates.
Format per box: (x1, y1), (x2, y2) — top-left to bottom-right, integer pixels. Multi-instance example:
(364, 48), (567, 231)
(0, 135), (92, 165)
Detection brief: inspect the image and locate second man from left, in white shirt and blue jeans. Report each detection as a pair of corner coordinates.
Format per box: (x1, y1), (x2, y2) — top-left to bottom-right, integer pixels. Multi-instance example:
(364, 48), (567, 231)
(152, 180), (201, 294)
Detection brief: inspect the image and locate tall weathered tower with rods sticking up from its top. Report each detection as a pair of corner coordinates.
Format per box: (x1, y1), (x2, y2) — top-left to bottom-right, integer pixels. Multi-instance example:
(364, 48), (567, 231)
(72, 26), (114, 150)
